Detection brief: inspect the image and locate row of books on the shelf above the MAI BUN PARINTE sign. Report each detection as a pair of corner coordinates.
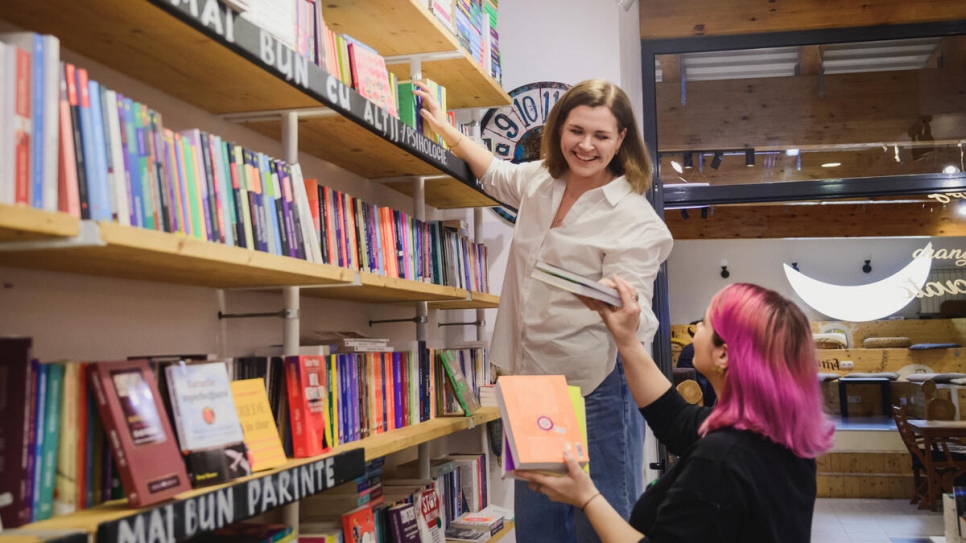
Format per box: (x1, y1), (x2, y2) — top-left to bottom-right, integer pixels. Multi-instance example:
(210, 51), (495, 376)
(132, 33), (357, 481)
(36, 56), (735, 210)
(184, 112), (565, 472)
(0, 338), (485, 527)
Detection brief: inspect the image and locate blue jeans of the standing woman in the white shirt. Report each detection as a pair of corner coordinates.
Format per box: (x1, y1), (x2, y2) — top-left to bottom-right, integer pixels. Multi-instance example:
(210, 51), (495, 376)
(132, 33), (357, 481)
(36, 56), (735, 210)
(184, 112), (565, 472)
(514, 355), (644, 543)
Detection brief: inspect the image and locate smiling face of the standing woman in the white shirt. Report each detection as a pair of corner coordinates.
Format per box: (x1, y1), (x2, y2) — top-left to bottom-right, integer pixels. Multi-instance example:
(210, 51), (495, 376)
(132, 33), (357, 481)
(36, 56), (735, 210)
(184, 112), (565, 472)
(560, 106), (627, 186)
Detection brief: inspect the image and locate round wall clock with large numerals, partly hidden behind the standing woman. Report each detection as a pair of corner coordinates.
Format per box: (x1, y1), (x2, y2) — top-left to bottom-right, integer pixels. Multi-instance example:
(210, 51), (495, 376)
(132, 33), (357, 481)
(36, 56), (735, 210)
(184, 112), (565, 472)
(480, 81), (570, 224)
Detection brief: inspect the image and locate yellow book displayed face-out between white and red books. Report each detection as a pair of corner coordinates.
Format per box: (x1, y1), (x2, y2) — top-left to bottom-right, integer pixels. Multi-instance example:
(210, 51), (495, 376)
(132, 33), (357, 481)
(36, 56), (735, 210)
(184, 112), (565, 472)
(231, 379), (286, 472)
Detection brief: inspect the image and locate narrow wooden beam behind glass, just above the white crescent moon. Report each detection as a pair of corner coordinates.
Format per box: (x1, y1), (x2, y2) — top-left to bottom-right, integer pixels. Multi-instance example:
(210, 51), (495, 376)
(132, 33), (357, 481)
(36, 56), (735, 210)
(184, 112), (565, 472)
(665, 203), (966, 240)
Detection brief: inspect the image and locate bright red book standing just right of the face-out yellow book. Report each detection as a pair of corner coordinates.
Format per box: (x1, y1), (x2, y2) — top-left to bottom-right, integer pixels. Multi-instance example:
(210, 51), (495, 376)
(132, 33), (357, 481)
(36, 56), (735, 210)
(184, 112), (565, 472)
(285, 356), (331, 458)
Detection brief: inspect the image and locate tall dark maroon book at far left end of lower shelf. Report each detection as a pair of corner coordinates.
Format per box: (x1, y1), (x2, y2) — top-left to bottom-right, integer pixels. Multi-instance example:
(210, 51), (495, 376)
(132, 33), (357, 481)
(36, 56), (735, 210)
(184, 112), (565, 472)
(0, 337), (35, 528)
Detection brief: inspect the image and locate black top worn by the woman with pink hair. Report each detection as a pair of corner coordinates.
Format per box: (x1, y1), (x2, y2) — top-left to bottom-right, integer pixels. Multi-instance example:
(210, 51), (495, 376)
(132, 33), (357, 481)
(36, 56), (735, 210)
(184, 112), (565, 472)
(630, 388), (816, 543)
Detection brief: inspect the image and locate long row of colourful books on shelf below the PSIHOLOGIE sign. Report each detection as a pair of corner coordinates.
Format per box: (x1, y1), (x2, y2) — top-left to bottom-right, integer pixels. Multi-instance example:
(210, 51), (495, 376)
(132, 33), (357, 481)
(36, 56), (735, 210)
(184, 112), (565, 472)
(0, 33), (489, 292)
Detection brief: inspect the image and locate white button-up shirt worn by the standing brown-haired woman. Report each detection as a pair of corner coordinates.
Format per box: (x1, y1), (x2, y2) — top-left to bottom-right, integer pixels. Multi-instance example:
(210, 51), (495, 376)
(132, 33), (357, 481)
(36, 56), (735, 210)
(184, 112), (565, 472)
(481, 159), (673, 396)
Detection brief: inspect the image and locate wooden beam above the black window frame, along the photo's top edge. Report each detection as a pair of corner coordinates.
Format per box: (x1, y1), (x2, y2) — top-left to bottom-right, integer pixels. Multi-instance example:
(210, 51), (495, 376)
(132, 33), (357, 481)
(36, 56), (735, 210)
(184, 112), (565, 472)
(640, 0), (966, 40)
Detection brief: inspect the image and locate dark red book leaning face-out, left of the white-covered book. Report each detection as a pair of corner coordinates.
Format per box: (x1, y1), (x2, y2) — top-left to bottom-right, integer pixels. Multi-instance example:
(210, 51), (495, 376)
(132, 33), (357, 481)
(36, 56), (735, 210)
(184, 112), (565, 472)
(89, 359), (191, 507)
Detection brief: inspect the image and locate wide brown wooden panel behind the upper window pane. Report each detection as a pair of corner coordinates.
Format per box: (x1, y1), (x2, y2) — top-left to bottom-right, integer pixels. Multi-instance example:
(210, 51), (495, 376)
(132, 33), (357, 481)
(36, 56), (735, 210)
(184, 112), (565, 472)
(657, 68), (966, 151)
